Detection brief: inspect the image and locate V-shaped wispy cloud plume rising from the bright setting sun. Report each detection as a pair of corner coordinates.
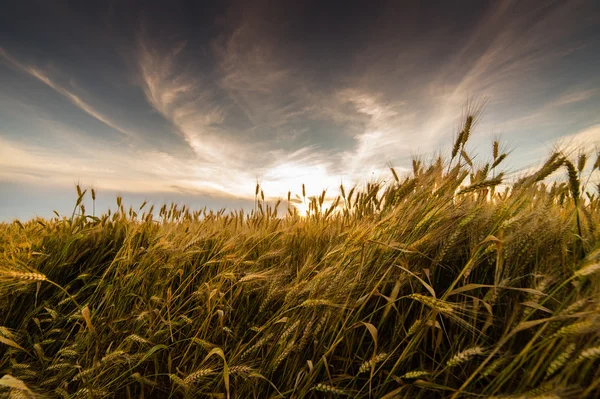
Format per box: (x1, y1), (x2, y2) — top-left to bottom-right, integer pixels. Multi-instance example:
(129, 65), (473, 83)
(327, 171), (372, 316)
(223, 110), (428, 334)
(138, 21), (360, 196)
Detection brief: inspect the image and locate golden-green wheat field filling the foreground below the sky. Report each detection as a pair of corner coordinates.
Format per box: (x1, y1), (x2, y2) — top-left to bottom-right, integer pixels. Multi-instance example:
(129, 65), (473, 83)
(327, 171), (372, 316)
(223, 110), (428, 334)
(0, 117), (600, 399)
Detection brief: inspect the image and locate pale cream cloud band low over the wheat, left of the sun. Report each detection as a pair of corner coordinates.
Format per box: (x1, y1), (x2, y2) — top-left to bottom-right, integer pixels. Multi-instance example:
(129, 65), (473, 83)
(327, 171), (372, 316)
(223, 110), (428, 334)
(0, 135), (244, 197)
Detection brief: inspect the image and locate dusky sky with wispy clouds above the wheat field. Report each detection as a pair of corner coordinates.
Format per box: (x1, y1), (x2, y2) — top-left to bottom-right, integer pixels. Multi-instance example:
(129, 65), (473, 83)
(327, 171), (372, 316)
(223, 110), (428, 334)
(0, 0), (600, 221)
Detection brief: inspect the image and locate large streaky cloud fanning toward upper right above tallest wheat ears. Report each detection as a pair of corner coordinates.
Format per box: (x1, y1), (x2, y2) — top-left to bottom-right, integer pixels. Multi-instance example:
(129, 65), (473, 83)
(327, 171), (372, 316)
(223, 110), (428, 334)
(346, 1), (593, 150)
